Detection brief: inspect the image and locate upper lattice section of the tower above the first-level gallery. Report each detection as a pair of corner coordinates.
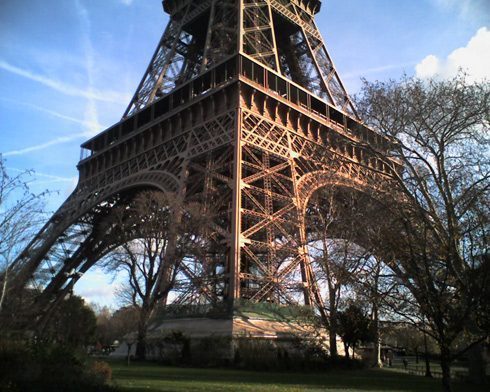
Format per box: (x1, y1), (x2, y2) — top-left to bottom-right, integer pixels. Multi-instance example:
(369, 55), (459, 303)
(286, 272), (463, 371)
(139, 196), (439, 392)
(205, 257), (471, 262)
(123, 0), (357, 118)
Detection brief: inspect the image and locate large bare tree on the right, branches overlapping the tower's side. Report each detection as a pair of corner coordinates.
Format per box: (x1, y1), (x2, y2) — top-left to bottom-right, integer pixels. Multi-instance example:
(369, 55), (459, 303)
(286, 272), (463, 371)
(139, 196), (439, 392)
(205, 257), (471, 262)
(358, 74), (490, 391)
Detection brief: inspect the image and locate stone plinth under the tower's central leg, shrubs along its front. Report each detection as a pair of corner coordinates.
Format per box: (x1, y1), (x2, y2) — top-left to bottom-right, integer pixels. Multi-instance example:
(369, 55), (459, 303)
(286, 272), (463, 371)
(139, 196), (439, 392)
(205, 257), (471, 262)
(111, 317), (352, 370)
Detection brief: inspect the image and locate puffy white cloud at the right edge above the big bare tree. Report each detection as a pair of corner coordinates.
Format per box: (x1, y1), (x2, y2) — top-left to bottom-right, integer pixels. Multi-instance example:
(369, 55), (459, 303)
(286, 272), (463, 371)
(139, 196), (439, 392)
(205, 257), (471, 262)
(415, 27), (490, 81)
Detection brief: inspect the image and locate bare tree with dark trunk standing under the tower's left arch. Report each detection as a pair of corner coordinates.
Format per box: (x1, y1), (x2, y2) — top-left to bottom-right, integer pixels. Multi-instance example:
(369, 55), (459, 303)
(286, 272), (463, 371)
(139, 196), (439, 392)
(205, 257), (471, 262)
(104, 191), (208, 359)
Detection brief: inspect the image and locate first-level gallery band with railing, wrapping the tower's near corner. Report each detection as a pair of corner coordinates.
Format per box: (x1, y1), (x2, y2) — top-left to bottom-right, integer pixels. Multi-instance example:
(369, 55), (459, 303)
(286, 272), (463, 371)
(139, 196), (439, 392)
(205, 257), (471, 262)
(79, 54), (390, 176)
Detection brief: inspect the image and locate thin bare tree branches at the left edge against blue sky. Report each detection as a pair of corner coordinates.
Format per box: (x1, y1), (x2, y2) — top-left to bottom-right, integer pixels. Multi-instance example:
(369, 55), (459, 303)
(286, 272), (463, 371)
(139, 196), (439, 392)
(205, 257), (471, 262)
(0, 155), (47, 313)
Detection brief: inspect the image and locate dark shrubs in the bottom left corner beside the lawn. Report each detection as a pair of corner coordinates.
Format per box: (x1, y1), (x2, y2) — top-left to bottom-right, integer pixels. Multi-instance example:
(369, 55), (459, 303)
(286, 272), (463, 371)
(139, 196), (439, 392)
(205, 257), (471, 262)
(0, 340), (112, 392)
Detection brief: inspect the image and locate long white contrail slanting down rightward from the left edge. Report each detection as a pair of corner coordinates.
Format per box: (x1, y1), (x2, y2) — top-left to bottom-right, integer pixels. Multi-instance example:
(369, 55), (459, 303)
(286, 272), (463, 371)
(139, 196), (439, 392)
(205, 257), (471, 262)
(0, 59), (131, 104)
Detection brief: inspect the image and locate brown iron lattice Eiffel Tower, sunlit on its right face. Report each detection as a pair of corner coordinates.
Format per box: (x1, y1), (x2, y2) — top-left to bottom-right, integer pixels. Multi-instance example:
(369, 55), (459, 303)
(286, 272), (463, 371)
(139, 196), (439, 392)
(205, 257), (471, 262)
(7, 0), (390, 334)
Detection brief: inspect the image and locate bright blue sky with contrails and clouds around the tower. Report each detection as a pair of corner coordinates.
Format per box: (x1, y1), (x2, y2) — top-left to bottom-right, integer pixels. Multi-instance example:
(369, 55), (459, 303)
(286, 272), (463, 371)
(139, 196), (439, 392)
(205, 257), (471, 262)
(0, 0), (490, 303)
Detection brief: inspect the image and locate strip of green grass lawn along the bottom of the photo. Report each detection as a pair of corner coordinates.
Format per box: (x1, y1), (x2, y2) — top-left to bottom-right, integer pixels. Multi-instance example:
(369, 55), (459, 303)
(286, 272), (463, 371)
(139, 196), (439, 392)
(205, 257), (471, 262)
(111, 362), (486, 392)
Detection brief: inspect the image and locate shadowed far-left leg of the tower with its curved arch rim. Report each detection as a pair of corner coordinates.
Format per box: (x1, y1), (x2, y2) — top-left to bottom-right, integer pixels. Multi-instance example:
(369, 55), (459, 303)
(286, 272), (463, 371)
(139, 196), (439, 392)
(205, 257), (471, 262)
(11, 171), (178, 314)
